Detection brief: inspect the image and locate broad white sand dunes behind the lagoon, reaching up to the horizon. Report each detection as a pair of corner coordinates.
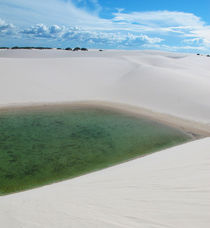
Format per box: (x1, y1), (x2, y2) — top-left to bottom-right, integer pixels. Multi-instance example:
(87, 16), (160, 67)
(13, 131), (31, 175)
(0, 50), (210, 124)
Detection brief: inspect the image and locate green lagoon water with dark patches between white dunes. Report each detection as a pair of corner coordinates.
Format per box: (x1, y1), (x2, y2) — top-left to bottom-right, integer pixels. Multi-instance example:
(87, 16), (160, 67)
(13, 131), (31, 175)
(0, 108), (191, 194)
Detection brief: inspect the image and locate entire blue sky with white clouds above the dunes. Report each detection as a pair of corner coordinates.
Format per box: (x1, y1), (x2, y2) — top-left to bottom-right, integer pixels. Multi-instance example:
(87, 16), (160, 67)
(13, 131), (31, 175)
(0, 0), (210, 53)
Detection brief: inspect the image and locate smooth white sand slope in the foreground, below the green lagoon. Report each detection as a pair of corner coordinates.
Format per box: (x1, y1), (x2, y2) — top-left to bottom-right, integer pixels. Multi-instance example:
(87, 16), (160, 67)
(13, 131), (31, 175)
(0, 138), (210, 228)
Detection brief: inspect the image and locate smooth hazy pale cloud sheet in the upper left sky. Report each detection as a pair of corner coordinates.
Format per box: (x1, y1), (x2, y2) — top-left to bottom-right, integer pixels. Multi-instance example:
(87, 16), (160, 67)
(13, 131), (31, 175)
(0, 0), (108, 28)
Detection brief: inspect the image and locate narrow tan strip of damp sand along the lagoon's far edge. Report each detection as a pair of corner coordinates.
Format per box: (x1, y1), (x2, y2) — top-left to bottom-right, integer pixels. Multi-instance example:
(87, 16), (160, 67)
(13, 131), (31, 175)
(0, 101), (210, 139)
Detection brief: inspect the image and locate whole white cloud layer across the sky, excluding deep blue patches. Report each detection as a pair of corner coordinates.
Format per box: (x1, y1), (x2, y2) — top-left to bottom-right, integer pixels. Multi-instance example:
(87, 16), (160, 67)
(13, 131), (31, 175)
(0, 0), (210, 52)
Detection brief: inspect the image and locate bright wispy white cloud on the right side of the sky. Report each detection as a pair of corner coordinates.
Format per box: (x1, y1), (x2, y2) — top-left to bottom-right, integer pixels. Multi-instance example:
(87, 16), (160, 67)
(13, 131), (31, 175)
(112, 11), (210, 48)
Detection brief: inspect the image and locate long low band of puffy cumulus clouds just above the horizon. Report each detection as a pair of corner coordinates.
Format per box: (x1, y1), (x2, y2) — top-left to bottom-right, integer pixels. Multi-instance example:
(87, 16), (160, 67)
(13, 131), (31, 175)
(20, 24), (163, 46)
